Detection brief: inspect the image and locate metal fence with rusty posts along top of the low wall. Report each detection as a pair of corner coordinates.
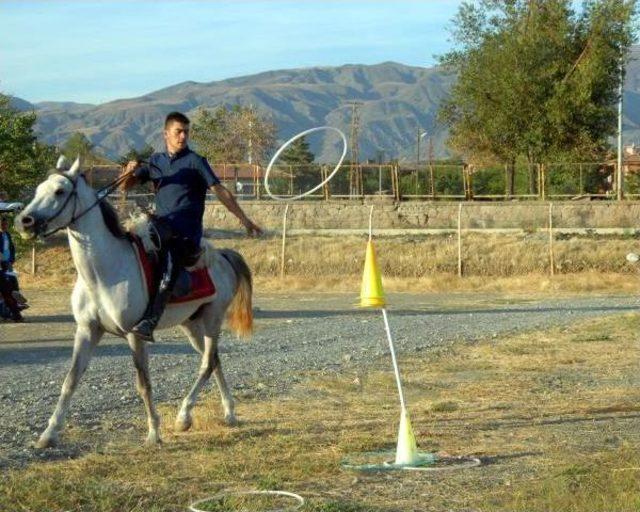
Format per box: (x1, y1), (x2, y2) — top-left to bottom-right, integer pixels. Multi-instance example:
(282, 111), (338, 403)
(86, 162), (640, 201)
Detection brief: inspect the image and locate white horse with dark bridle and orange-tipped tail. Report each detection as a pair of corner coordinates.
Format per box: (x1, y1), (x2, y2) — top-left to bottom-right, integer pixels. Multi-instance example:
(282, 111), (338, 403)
(15, 160), (253, 448)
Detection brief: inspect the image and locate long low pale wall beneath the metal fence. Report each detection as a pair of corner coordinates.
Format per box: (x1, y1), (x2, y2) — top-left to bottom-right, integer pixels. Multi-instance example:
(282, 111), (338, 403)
(204, 200), (640, 230)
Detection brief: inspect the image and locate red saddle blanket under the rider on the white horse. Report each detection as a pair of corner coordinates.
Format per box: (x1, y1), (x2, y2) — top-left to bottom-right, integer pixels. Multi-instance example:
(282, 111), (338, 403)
(129, 232), (216, 304)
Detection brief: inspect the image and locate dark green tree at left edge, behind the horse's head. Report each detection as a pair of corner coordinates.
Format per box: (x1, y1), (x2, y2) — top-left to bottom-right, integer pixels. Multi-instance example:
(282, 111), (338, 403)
(0, 94), (55, 200)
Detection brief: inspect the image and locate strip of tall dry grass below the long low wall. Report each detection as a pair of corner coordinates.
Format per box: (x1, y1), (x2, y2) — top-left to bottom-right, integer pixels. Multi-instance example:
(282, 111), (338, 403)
(17, 234), (640, 293)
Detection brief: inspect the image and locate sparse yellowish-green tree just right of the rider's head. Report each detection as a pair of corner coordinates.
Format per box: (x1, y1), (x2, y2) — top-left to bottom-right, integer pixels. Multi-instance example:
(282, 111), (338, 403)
(192, 105), (276, 163)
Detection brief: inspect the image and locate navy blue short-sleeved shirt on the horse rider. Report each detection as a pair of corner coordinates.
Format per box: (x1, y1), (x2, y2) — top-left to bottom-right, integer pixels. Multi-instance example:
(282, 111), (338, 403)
(135, 147), (220, 245)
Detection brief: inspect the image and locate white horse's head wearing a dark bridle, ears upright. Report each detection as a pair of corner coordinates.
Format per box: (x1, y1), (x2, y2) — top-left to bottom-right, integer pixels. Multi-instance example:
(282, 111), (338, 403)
(15, 156), (80, 238)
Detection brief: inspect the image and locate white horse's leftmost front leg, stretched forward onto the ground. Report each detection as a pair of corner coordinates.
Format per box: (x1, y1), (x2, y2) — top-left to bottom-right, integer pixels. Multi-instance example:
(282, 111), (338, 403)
(36, 325), (104, 448)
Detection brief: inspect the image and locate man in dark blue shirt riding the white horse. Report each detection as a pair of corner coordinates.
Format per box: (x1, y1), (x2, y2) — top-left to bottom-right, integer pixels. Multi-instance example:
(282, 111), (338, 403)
(123, 112), (262, 341)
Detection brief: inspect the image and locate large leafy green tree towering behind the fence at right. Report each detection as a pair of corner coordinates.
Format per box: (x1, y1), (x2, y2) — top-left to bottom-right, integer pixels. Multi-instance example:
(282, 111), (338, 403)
(439, 0), (636, 194)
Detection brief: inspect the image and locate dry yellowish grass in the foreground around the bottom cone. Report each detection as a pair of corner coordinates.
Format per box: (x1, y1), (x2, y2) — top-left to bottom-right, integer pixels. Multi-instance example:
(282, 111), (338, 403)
(0, 315), (640, 512)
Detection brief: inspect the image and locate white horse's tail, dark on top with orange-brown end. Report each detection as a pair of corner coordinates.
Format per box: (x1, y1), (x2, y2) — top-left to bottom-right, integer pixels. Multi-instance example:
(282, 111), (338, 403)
(220, 249), (253, 337)
